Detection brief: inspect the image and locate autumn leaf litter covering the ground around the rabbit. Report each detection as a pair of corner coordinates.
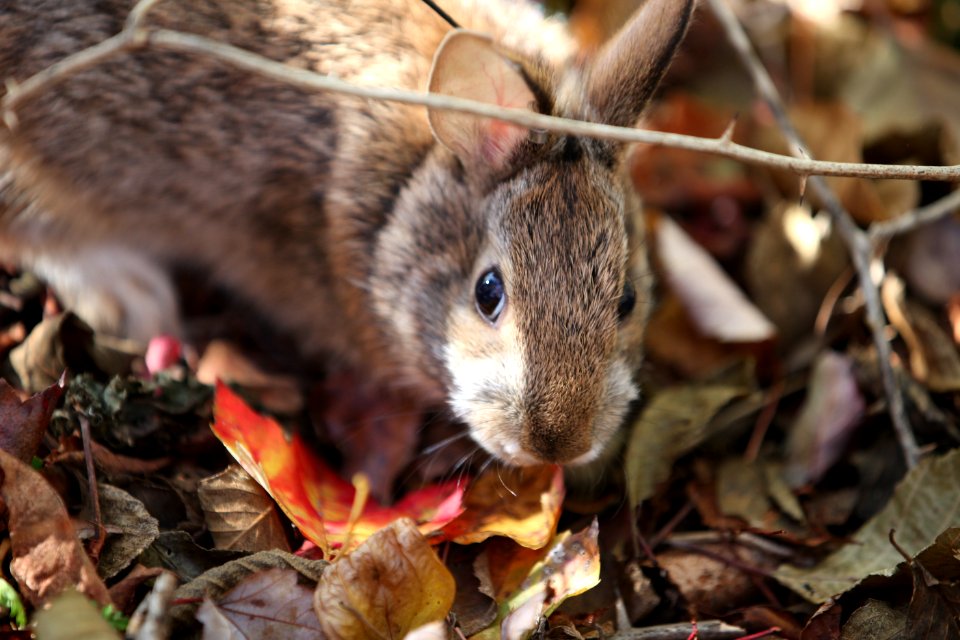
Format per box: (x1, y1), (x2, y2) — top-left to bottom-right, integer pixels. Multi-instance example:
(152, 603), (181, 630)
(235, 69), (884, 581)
(0, 0), (960, 640)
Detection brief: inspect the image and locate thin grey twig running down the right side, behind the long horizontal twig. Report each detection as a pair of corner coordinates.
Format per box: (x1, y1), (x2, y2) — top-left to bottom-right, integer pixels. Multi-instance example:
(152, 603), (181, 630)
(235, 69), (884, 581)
(708, 0), (920, 469)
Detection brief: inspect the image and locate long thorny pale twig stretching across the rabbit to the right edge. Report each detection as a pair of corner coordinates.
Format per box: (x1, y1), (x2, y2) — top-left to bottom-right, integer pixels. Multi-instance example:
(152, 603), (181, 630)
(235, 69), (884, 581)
(0, 15), (960, 182)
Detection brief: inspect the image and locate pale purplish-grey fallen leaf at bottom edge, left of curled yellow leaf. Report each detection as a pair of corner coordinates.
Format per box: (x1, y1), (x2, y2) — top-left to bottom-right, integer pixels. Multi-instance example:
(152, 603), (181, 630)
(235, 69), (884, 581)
(197, 569), (323, 640)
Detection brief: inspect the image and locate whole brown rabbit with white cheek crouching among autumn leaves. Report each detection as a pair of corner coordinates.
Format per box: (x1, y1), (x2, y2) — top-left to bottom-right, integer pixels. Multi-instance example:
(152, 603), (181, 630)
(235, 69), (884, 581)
(0, 0), (694, 466)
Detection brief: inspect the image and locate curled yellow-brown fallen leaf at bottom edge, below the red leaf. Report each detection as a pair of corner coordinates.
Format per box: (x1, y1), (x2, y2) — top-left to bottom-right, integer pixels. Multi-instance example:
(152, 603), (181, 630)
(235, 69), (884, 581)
(314, 518), (456, 640)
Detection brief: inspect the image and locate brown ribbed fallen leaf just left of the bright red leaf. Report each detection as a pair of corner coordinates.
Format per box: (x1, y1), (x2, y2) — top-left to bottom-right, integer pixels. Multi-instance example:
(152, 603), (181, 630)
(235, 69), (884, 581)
(197, 465), (290, 553)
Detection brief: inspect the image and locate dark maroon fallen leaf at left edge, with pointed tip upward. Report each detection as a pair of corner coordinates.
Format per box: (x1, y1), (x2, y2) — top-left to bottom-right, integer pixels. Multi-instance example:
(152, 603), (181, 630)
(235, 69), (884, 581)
(0, 378), (63, 462)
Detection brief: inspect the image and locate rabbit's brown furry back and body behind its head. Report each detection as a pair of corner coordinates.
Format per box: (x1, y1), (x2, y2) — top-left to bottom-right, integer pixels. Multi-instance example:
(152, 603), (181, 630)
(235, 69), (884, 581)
(0, 0), (462, 351)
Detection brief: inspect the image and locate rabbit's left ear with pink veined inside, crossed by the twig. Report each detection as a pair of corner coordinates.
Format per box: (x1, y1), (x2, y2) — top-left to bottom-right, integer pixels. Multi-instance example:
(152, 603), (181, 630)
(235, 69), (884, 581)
(429, 30), (536, 170)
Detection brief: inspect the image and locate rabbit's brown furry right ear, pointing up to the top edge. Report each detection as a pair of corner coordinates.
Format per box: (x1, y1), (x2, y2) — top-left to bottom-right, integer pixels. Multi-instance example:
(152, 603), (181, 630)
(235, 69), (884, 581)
(587, 0), (696, 127)
